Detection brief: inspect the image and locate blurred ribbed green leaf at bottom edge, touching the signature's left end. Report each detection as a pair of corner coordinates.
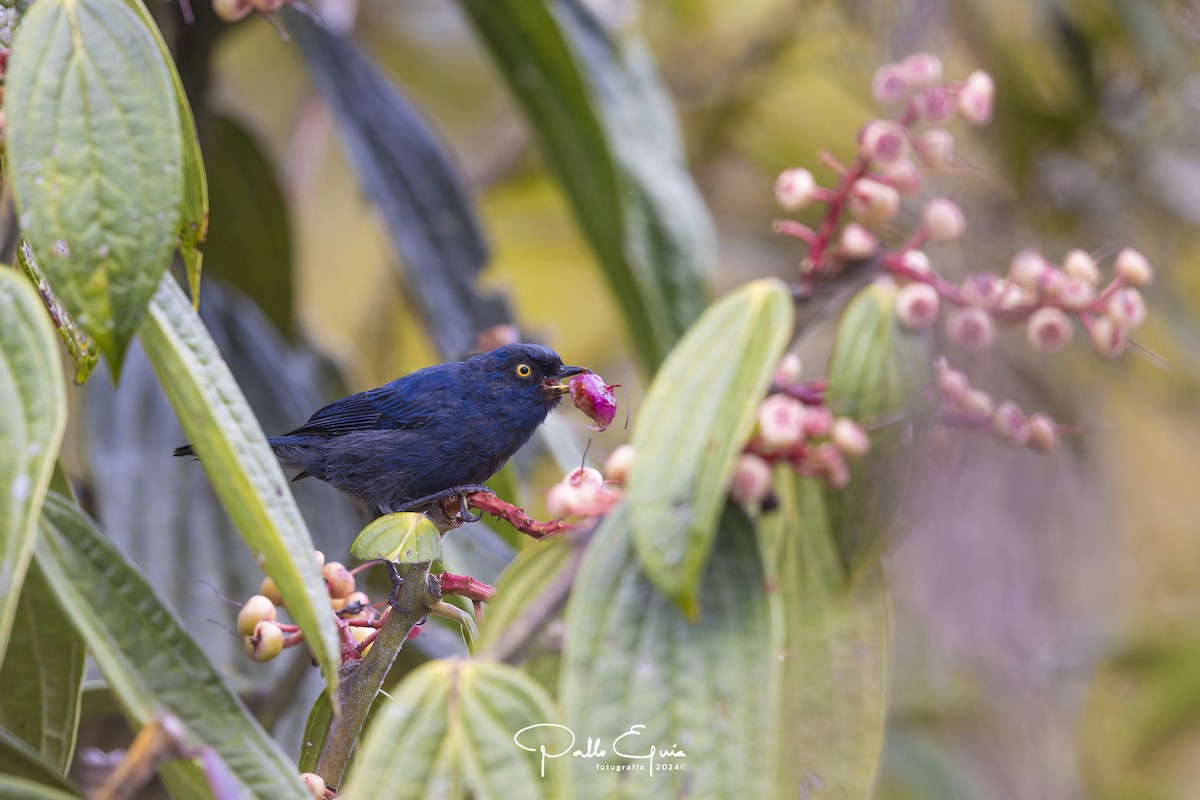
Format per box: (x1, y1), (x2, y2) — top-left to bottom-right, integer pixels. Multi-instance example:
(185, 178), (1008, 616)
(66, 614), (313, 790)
(342, 658), (563, 800)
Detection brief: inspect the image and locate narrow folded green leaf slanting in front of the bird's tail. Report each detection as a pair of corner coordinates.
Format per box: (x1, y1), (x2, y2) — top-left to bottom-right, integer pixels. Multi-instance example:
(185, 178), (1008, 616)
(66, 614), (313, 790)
(142, 276), (341, 694)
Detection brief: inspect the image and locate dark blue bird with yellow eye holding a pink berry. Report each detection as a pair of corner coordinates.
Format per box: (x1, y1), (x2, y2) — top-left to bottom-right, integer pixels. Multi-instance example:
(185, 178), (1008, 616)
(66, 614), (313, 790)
(175, 344), (587, 517)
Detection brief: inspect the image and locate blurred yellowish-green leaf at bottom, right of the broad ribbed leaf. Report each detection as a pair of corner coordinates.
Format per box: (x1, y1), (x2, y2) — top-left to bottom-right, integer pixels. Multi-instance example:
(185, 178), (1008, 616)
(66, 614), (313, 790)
(761, 468), (892, 800)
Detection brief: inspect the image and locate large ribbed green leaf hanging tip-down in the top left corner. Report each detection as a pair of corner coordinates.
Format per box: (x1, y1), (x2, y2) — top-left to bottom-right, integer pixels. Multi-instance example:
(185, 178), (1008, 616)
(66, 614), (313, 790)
(5, 0), (184, 375)
